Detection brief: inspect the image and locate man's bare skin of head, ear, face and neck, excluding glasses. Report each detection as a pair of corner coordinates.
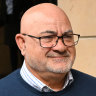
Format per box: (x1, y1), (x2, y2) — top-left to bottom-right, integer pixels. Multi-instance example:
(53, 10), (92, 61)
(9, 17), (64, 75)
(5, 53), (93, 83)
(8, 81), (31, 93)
(16, 3), (76, 91)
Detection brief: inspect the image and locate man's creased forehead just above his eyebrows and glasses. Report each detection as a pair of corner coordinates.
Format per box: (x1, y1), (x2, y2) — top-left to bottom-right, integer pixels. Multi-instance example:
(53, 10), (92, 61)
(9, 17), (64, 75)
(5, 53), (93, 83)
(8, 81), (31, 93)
(29, 21), (72, 35)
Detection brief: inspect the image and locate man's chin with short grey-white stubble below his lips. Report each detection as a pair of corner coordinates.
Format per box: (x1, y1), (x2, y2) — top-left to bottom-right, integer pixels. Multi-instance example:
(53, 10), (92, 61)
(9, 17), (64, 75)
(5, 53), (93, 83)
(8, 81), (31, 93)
(47, 58), (74, 74)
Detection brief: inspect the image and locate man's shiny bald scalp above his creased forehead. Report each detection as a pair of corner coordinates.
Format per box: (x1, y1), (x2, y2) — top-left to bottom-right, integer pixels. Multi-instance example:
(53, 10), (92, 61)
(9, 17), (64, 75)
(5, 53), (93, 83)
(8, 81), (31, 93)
(21, 3), (70, 33)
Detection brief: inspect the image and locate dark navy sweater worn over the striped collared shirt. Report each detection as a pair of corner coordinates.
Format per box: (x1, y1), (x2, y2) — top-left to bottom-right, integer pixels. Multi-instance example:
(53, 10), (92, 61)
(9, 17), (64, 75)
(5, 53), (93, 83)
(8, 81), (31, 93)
(0, 69), (96, 96)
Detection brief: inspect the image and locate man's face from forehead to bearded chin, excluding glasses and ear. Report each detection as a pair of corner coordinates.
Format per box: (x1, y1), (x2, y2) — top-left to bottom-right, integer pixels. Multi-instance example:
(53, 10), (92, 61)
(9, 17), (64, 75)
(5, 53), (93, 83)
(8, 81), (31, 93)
(25, 14), (75, 73)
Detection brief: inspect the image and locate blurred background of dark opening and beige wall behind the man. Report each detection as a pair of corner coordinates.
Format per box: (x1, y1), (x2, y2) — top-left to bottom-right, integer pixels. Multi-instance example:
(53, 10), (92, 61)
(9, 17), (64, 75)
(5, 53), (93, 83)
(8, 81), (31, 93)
(0, 0), (96, 78)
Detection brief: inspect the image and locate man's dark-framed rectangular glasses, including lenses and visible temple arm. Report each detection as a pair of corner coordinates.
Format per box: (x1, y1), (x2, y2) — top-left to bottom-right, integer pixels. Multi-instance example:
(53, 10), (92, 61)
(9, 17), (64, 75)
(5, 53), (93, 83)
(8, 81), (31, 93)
(22, 34), (80, 48)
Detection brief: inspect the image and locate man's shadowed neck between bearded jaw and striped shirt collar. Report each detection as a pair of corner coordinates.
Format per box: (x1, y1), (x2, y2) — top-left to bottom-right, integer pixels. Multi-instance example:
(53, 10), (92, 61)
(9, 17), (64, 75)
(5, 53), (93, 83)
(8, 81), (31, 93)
(27, 63), (66, 91)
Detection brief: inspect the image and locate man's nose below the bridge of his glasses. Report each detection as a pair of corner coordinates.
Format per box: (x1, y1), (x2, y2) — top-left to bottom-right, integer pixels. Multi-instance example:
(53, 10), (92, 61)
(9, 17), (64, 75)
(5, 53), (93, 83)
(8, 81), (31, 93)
(52, 38), (67, 52)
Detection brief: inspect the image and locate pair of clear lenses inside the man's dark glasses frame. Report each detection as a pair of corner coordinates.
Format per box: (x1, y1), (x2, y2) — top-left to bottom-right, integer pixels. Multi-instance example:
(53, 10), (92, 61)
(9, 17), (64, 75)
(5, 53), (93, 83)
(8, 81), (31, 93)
(40, 34), (79, 48)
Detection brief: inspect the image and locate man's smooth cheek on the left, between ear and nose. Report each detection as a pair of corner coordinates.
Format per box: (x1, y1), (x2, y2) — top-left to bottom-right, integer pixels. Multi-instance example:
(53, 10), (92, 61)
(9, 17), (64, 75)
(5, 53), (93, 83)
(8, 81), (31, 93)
(26, 37), (49, 62)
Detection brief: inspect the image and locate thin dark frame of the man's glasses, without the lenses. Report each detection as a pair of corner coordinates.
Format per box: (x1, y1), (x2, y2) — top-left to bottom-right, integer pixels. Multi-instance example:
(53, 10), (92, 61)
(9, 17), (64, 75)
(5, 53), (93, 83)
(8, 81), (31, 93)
(22, 33), (80, 48)
